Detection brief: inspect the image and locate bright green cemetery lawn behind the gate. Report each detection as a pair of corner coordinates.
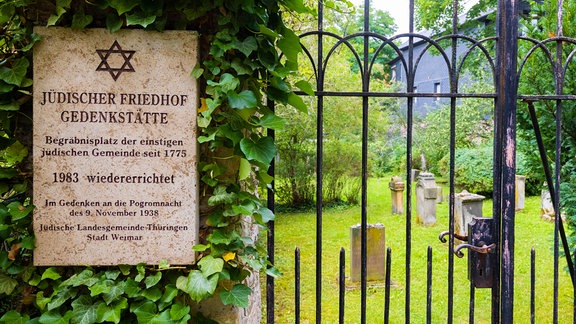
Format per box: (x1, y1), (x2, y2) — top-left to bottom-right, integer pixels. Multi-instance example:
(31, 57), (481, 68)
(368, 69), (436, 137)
(264, 178), (573, 323)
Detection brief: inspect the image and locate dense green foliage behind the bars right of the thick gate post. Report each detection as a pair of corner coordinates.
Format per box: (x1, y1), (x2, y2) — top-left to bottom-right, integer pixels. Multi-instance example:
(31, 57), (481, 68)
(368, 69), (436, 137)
(518, 0), (576, 253)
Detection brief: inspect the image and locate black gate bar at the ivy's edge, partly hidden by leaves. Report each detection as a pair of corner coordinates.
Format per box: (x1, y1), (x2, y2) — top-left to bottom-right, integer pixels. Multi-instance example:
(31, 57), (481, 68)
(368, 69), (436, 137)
(266, 100), (276, 324)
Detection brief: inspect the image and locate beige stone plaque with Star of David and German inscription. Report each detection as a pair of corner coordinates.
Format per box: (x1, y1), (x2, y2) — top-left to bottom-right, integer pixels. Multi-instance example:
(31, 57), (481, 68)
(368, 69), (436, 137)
(33, 28), (198, 265)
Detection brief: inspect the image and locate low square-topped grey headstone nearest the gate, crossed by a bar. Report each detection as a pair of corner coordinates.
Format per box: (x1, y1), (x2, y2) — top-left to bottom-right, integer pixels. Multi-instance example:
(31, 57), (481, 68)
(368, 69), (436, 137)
(350, 224), (386, 282)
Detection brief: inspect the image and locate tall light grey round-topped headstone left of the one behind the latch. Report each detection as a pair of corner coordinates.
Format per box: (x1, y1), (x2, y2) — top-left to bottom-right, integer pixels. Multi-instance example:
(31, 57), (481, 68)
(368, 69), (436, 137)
(416, 172), (438, 226)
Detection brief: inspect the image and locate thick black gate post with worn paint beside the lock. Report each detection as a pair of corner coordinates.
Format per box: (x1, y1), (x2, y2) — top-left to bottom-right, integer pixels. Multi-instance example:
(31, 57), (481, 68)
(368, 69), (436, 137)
(495, 0), (519, 323)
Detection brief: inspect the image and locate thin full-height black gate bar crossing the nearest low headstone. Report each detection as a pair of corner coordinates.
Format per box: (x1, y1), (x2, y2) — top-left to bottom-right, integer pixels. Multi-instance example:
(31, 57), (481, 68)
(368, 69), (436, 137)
(360, 0), (370, 324)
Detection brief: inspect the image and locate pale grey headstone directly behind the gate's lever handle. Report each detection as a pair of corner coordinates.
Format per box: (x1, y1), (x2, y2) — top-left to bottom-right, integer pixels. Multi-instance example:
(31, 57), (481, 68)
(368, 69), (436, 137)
(454, 190), (485, 236)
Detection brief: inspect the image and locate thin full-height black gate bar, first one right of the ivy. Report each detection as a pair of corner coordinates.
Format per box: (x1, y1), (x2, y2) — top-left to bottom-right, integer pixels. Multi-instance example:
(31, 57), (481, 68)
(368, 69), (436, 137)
(316, 1), (325, 324)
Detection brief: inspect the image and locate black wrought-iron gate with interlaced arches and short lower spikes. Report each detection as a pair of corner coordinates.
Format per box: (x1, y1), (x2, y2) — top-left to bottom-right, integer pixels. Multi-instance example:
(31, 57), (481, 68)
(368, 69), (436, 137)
(266, 0), (576, 323)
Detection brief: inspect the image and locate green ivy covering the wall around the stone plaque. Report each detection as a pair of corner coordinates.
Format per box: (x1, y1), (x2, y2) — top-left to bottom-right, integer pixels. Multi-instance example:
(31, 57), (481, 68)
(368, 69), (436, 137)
(0, 0), (311, 323)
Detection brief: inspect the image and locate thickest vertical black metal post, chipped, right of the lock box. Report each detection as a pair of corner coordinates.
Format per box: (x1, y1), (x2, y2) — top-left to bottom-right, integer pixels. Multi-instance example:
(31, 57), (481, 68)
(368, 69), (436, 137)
(492, 0), (520, 323)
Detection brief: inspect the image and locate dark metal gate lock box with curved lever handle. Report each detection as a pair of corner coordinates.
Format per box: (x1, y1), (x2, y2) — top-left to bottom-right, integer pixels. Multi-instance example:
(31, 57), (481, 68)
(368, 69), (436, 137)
(454, 217), (496, 288)
